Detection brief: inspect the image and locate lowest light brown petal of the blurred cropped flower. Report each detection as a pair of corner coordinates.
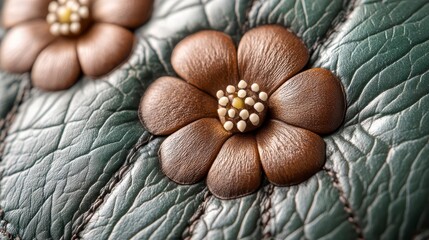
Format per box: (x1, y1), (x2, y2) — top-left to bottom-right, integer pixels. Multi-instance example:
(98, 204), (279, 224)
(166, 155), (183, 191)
(31, 38), (80, 91)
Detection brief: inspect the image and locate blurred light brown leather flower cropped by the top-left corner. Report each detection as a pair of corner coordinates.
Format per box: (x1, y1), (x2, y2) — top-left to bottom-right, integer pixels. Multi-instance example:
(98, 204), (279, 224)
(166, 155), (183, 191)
(0, 0), (152, 90)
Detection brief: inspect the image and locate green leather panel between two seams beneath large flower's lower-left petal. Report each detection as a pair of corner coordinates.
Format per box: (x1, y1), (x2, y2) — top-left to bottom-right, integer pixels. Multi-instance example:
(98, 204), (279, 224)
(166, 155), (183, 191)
(83, 139), (205, 239)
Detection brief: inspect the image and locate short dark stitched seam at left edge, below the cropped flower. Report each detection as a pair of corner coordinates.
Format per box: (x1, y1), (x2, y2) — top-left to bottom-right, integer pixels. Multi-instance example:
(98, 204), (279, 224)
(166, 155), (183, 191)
(0, 78), (31, 162)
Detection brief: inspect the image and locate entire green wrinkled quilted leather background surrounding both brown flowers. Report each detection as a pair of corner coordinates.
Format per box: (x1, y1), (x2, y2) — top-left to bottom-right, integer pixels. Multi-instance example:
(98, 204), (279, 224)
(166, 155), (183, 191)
(0, 0), (429, 239)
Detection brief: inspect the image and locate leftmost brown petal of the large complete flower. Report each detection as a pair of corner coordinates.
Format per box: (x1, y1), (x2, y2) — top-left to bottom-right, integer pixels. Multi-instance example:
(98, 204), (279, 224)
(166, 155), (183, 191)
(140, 77), (217, 135)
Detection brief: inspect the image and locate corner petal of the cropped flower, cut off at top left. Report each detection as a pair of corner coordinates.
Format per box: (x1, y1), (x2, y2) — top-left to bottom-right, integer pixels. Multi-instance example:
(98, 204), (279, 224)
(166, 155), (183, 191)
(2, 0), (52, 28)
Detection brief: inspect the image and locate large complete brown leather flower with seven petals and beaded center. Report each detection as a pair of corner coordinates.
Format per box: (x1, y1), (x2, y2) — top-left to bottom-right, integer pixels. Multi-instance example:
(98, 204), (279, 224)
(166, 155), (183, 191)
(140, 25), (346, 199)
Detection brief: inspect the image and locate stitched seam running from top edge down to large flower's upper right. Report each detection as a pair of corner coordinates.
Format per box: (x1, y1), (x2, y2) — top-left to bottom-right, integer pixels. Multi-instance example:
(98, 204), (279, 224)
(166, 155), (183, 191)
(309, 0), (360, 55)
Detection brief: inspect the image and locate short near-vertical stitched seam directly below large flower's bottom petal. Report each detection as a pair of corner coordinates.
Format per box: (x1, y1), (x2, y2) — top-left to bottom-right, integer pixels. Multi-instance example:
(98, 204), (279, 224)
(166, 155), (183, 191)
(261, 184), (274, 239)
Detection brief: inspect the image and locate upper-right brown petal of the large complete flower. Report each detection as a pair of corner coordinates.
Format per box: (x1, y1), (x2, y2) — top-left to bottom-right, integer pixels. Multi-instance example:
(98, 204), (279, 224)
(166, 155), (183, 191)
(238, 25), (309, 94)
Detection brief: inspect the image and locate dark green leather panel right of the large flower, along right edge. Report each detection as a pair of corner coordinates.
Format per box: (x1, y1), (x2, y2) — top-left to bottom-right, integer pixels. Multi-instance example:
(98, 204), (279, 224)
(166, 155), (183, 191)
(317, 0), (429, 239)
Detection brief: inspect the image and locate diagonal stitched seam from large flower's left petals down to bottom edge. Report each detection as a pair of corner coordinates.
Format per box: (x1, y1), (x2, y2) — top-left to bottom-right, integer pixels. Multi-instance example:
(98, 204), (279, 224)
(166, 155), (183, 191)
(72, 135), (153, 240)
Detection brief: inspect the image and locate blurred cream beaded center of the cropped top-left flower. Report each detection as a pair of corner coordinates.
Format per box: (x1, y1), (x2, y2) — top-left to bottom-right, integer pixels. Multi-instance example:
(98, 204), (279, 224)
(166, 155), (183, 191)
(46, 0), (89, 36)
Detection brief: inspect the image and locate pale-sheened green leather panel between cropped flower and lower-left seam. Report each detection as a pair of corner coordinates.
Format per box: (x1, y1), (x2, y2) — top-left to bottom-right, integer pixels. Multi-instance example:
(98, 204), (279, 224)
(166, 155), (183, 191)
(0, 45), (151, 239)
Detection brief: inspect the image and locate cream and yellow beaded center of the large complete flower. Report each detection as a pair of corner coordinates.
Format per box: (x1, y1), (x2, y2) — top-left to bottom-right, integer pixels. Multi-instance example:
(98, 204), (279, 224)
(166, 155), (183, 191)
(216, 80), (268, 132)
